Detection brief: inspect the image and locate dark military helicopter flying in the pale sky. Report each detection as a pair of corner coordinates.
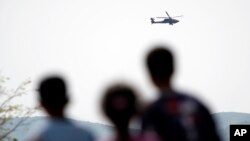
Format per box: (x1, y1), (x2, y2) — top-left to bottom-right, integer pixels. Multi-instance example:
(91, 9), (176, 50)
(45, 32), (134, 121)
(150, 11), (183, 25)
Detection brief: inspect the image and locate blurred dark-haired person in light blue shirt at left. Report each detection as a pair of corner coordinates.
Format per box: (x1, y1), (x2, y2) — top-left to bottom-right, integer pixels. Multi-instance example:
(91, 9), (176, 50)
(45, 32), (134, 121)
(30, 76), (94, 141)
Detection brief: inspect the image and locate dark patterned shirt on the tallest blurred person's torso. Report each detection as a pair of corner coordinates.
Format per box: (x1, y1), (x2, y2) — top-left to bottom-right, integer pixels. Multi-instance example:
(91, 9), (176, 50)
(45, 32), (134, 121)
(142, 91), (219, 141)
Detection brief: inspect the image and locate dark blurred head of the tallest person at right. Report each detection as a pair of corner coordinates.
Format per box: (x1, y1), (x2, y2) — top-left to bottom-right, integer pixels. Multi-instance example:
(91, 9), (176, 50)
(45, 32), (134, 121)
(146, 45), (174, 88)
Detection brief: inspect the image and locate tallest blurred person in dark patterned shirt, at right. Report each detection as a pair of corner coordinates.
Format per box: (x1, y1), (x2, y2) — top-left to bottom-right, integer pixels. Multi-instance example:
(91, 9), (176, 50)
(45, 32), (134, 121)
(142, 45), (220, 141)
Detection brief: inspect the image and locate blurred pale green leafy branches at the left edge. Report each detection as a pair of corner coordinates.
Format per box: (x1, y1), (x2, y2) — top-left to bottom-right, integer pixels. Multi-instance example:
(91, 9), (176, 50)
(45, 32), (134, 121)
(0, 74), (35, 141)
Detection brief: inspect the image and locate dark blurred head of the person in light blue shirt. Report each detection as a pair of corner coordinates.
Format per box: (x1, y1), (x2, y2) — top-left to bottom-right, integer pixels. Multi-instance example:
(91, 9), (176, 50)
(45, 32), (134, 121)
(39, 76), (68, 116)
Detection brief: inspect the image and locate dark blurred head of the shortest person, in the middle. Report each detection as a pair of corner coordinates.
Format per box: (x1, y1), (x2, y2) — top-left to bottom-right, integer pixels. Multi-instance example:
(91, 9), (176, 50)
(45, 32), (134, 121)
(102, 84), (137, 128)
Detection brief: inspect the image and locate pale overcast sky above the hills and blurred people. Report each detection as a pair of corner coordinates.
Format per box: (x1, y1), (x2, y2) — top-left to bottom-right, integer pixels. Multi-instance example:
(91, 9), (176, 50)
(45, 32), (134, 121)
(0, 0), (250, 123)
